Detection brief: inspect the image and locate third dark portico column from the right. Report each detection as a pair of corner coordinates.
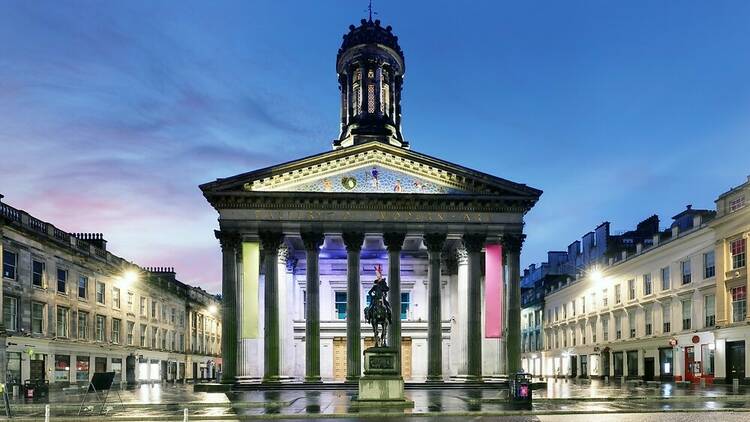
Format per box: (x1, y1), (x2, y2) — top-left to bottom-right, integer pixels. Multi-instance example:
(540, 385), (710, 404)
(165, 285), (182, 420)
(424, 233), (446, 381)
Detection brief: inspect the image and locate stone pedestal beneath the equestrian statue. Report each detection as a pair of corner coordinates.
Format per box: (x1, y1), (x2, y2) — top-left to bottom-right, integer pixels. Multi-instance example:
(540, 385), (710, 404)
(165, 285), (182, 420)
(357, 347), (414, 407)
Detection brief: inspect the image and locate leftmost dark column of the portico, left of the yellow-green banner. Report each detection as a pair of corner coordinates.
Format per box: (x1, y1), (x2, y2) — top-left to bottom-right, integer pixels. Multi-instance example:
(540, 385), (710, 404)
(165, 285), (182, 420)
(214, 230), (240, 384)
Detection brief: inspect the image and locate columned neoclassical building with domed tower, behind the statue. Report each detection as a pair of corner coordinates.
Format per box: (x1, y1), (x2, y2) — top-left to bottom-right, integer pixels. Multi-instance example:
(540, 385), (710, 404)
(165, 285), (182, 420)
(201, 20), (541, 383)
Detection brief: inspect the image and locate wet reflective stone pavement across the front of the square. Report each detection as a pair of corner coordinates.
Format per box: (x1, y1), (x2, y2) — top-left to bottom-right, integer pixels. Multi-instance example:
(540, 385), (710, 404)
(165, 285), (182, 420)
(4, 380), (750, 422)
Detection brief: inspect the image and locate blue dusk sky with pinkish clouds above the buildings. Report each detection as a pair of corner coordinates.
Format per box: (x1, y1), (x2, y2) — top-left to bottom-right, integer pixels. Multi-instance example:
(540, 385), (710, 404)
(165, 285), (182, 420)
(0, 0), (750, 292)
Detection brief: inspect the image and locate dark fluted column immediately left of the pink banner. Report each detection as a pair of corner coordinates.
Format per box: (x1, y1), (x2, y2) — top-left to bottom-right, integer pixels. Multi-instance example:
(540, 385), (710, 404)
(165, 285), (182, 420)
(463, 233), (486, 380)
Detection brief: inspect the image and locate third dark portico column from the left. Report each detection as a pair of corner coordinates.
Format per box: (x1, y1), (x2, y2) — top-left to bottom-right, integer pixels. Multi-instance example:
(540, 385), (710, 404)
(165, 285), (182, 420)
(302, 233), (325, 383)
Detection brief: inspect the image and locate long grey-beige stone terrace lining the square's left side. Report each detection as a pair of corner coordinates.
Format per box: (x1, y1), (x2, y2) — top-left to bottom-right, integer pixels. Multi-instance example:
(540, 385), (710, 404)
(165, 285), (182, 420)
(0, 196), (221, 386)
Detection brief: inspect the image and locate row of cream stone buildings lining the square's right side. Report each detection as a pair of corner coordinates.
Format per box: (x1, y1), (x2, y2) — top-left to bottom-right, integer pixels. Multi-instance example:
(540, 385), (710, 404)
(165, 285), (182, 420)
(523, 178), (750, 383)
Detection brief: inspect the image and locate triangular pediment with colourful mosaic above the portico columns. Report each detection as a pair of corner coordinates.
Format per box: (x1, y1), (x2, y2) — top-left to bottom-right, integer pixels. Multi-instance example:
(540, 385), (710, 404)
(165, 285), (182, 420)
(201, 142), (541, 199)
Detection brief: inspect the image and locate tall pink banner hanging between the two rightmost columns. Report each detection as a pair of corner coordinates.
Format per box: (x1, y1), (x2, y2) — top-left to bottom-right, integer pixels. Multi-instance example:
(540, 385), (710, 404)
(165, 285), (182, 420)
(484, 244), (503, 338)
